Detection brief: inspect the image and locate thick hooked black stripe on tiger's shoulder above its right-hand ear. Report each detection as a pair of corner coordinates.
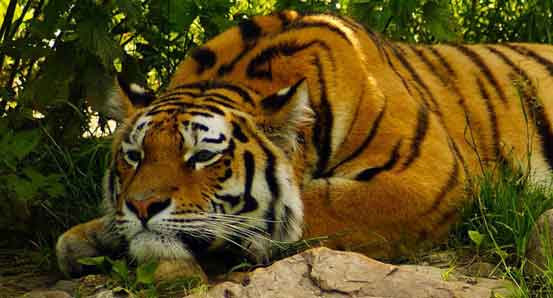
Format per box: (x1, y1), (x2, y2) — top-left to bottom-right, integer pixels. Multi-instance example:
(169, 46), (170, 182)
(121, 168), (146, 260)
(246, 40), (330, 80)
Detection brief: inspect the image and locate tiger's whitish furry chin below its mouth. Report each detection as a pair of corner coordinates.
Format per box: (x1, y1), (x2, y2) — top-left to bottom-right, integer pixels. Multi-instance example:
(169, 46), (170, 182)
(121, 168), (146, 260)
(129, 231), (194, 262)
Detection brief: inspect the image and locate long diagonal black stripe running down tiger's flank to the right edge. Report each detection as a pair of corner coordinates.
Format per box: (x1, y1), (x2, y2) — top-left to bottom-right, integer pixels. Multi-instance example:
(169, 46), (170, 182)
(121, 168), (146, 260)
(488, 44), (553, 168)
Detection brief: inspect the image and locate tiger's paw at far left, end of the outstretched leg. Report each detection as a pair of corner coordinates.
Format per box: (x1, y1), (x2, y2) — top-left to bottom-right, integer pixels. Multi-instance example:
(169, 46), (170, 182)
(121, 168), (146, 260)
(56, 229), (100, 277)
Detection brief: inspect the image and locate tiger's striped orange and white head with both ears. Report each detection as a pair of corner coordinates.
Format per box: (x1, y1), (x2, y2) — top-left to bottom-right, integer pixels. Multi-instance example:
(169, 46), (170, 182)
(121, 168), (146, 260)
(104, 81), (309, 260)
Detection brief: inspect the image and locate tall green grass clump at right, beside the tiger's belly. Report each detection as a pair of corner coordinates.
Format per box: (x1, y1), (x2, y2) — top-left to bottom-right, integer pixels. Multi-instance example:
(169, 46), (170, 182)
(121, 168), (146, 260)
(450, 164), (553, 297)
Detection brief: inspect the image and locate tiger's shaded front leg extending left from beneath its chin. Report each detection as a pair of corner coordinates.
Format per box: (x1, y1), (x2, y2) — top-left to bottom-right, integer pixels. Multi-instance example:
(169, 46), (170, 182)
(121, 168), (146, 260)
(56, 216), (124, 277)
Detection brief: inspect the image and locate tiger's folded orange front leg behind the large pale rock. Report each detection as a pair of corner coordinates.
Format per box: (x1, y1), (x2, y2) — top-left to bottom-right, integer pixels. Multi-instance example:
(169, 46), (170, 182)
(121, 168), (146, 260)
(302, 150), (464, 257)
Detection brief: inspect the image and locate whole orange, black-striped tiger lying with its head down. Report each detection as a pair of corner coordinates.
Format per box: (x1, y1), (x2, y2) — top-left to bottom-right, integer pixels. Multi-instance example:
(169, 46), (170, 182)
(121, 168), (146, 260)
(56, 11), (553, 276)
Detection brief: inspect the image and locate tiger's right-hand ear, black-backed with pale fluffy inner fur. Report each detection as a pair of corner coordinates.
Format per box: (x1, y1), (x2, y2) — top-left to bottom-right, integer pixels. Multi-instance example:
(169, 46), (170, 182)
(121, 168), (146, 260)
(258, 79), (314, 152)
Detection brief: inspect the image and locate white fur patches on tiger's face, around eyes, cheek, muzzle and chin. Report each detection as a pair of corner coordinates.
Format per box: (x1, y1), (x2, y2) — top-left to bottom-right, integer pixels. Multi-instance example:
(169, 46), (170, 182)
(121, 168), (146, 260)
(106, 108), (303, 260)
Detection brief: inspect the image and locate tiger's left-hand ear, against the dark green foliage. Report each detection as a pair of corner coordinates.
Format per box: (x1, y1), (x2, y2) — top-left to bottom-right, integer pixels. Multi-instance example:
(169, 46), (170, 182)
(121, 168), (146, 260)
(106, 77), (155, 122)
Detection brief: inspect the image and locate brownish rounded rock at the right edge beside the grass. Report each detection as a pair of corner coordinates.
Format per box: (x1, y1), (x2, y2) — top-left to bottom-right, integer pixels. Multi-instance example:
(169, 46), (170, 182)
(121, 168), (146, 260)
(526, 209), (553, 274)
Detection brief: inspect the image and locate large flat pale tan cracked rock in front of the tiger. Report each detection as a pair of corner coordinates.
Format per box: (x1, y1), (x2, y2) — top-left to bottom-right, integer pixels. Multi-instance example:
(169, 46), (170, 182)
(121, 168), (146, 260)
(187, 248), (512, 298)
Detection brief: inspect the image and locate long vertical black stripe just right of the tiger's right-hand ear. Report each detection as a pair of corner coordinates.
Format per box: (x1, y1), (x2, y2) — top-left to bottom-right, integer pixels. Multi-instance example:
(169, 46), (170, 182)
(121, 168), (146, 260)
(313, 56), (334, 178)
